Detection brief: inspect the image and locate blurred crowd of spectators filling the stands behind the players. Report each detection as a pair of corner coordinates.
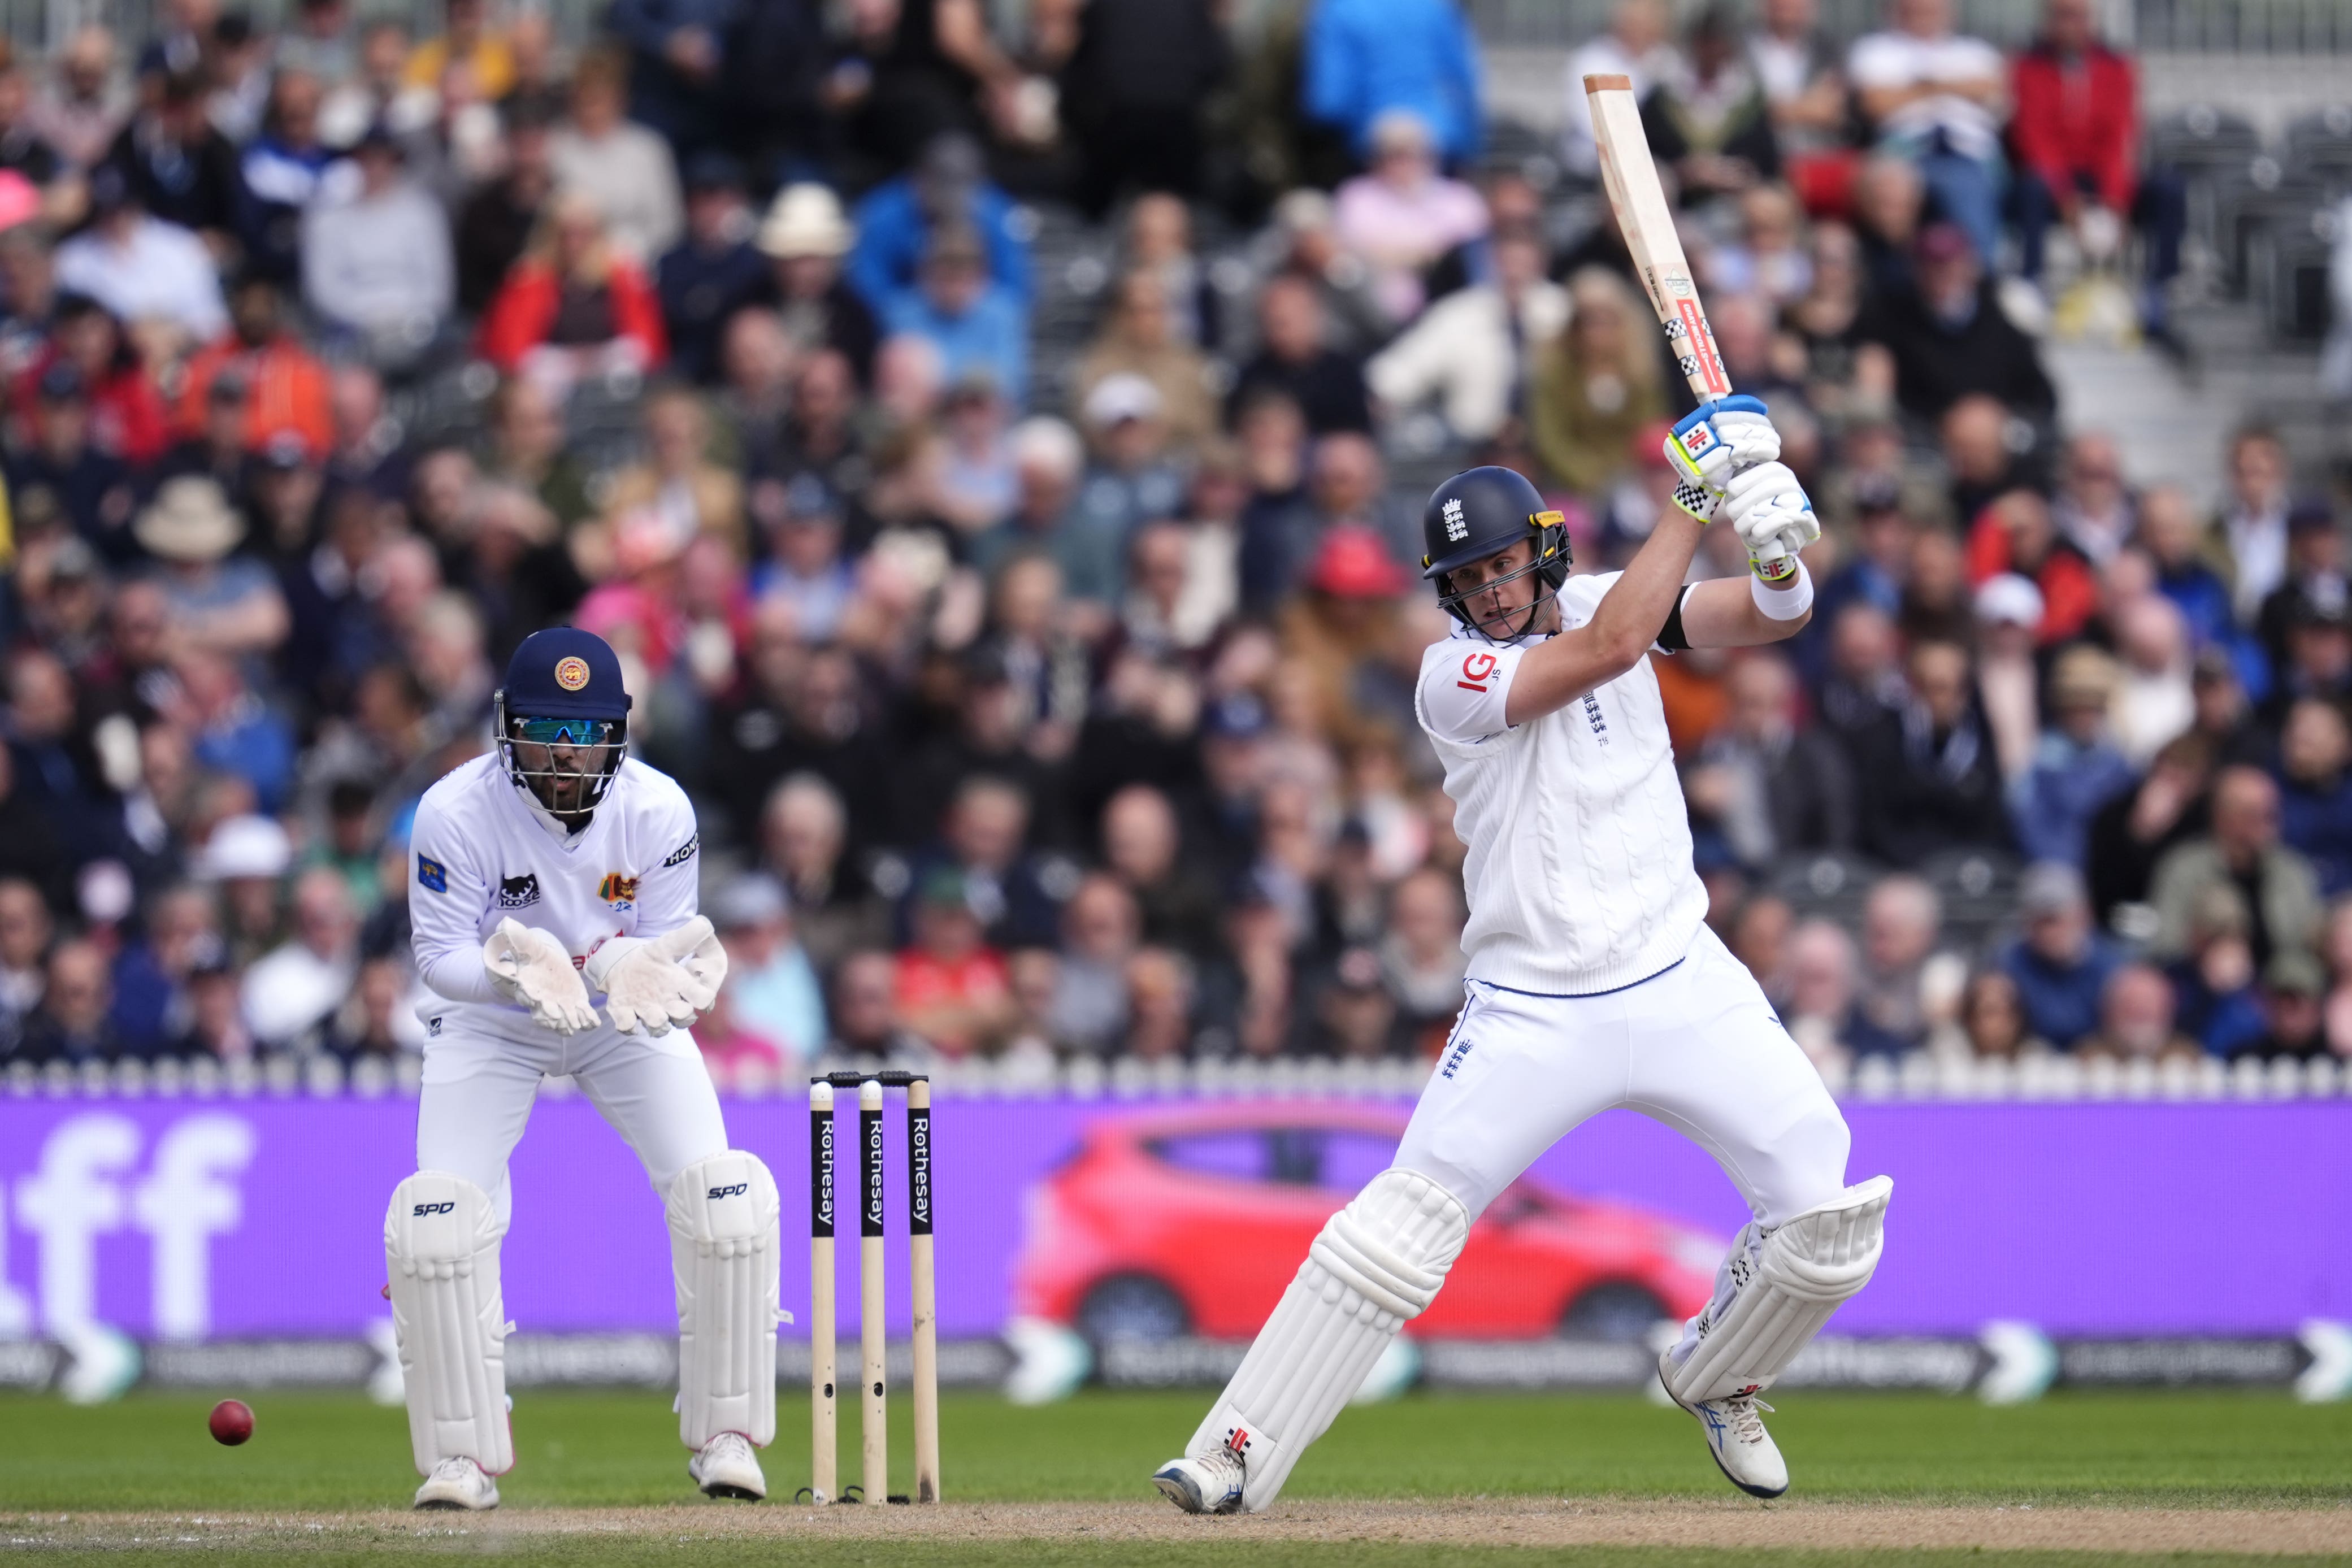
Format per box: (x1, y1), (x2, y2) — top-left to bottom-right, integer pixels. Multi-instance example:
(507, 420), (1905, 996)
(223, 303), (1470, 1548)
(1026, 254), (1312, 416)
(0, 0), (2352, 1081)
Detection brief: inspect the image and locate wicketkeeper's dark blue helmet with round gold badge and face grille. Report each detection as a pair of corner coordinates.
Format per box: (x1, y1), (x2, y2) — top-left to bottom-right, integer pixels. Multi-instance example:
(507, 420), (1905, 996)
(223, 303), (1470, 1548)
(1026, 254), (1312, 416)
(492, 626), (630, 816)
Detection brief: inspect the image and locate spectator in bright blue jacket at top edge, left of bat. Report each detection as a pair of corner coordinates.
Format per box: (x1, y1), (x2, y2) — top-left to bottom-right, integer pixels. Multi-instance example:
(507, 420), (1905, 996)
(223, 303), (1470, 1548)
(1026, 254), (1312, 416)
(1301, 0), (1482, 164)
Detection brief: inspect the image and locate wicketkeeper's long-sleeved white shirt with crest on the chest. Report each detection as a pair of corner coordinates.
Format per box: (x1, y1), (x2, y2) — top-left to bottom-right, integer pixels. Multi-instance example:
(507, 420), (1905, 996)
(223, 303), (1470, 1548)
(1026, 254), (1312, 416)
(409, 752), (701, 1039)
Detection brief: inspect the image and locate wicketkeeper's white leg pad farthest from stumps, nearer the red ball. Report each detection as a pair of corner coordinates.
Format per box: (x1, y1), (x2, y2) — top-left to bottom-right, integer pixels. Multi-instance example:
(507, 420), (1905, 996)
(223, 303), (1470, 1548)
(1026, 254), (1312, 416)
(383, 1171), (515, 1476)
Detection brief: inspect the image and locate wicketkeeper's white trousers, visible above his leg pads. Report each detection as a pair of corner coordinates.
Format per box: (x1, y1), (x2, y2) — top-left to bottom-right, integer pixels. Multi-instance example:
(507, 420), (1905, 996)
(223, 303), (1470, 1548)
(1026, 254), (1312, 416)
(416, 1027), (727, 1230)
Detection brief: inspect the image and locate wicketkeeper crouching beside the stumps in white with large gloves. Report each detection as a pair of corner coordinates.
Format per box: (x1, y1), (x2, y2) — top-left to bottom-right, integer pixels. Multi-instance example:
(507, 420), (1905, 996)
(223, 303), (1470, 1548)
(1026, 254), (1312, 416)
(383, 628), (781, 1509)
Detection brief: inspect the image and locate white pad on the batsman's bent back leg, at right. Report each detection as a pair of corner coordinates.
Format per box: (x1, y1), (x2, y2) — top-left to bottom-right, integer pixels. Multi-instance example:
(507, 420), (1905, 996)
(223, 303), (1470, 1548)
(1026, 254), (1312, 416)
(1665, 1175), (1896, 1404)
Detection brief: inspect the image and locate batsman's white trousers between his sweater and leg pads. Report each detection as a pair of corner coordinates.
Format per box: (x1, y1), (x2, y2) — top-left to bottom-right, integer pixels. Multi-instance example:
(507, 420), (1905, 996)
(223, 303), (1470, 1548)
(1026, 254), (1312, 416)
(1397, 926), (1851, 1337)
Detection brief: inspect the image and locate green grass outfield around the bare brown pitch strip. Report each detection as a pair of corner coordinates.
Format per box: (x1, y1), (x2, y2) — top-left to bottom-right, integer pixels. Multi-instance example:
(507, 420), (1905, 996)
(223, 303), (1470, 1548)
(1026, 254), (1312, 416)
(0, 1389), (2352, 1568)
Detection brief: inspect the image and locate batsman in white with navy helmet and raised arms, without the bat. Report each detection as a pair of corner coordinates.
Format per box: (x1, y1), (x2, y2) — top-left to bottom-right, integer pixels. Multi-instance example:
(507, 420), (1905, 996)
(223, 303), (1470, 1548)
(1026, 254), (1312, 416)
(1152, 397), (1893, 1514)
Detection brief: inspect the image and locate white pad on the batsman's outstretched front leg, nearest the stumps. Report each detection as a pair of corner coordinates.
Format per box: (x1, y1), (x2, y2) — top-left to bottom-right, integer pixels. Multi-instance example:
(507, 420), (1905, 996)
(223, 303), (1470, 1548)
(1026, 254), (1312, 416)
(1186, 1171), (1470, 1514)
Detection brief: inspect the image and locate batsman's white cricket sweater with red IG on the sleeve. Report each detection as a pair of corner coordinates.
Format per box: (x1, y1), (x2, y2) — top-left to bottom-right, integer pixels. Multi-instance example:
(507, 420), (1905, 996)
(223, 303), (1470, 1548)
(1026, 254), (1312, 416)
(1413, 571), (1708, 997)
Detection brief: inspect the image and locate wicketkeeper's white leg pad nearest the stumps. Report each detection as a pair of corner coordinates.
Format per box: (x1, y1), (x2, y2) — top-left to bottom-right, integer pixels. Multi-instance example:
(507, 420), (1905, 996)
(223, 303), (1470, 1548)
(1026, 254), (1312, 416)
(668, 1149), (783, 1448)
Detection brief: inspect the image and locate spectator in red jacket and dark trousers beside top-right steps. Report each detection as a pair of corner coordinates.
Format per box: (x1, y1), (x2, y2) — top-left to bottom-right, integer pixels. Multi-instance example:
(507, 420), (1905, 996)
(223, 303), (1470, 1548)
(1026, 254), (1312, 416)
(2008, 0), (2188, 343)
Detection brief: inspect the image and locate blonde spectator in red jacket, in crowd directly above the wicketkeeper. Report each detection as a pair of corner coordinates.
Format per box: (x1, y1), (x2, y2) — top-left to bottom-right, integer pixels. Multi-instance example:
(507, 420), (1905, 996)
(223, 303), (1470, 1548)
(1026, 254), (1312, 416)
(480, 193), (668, 385)
